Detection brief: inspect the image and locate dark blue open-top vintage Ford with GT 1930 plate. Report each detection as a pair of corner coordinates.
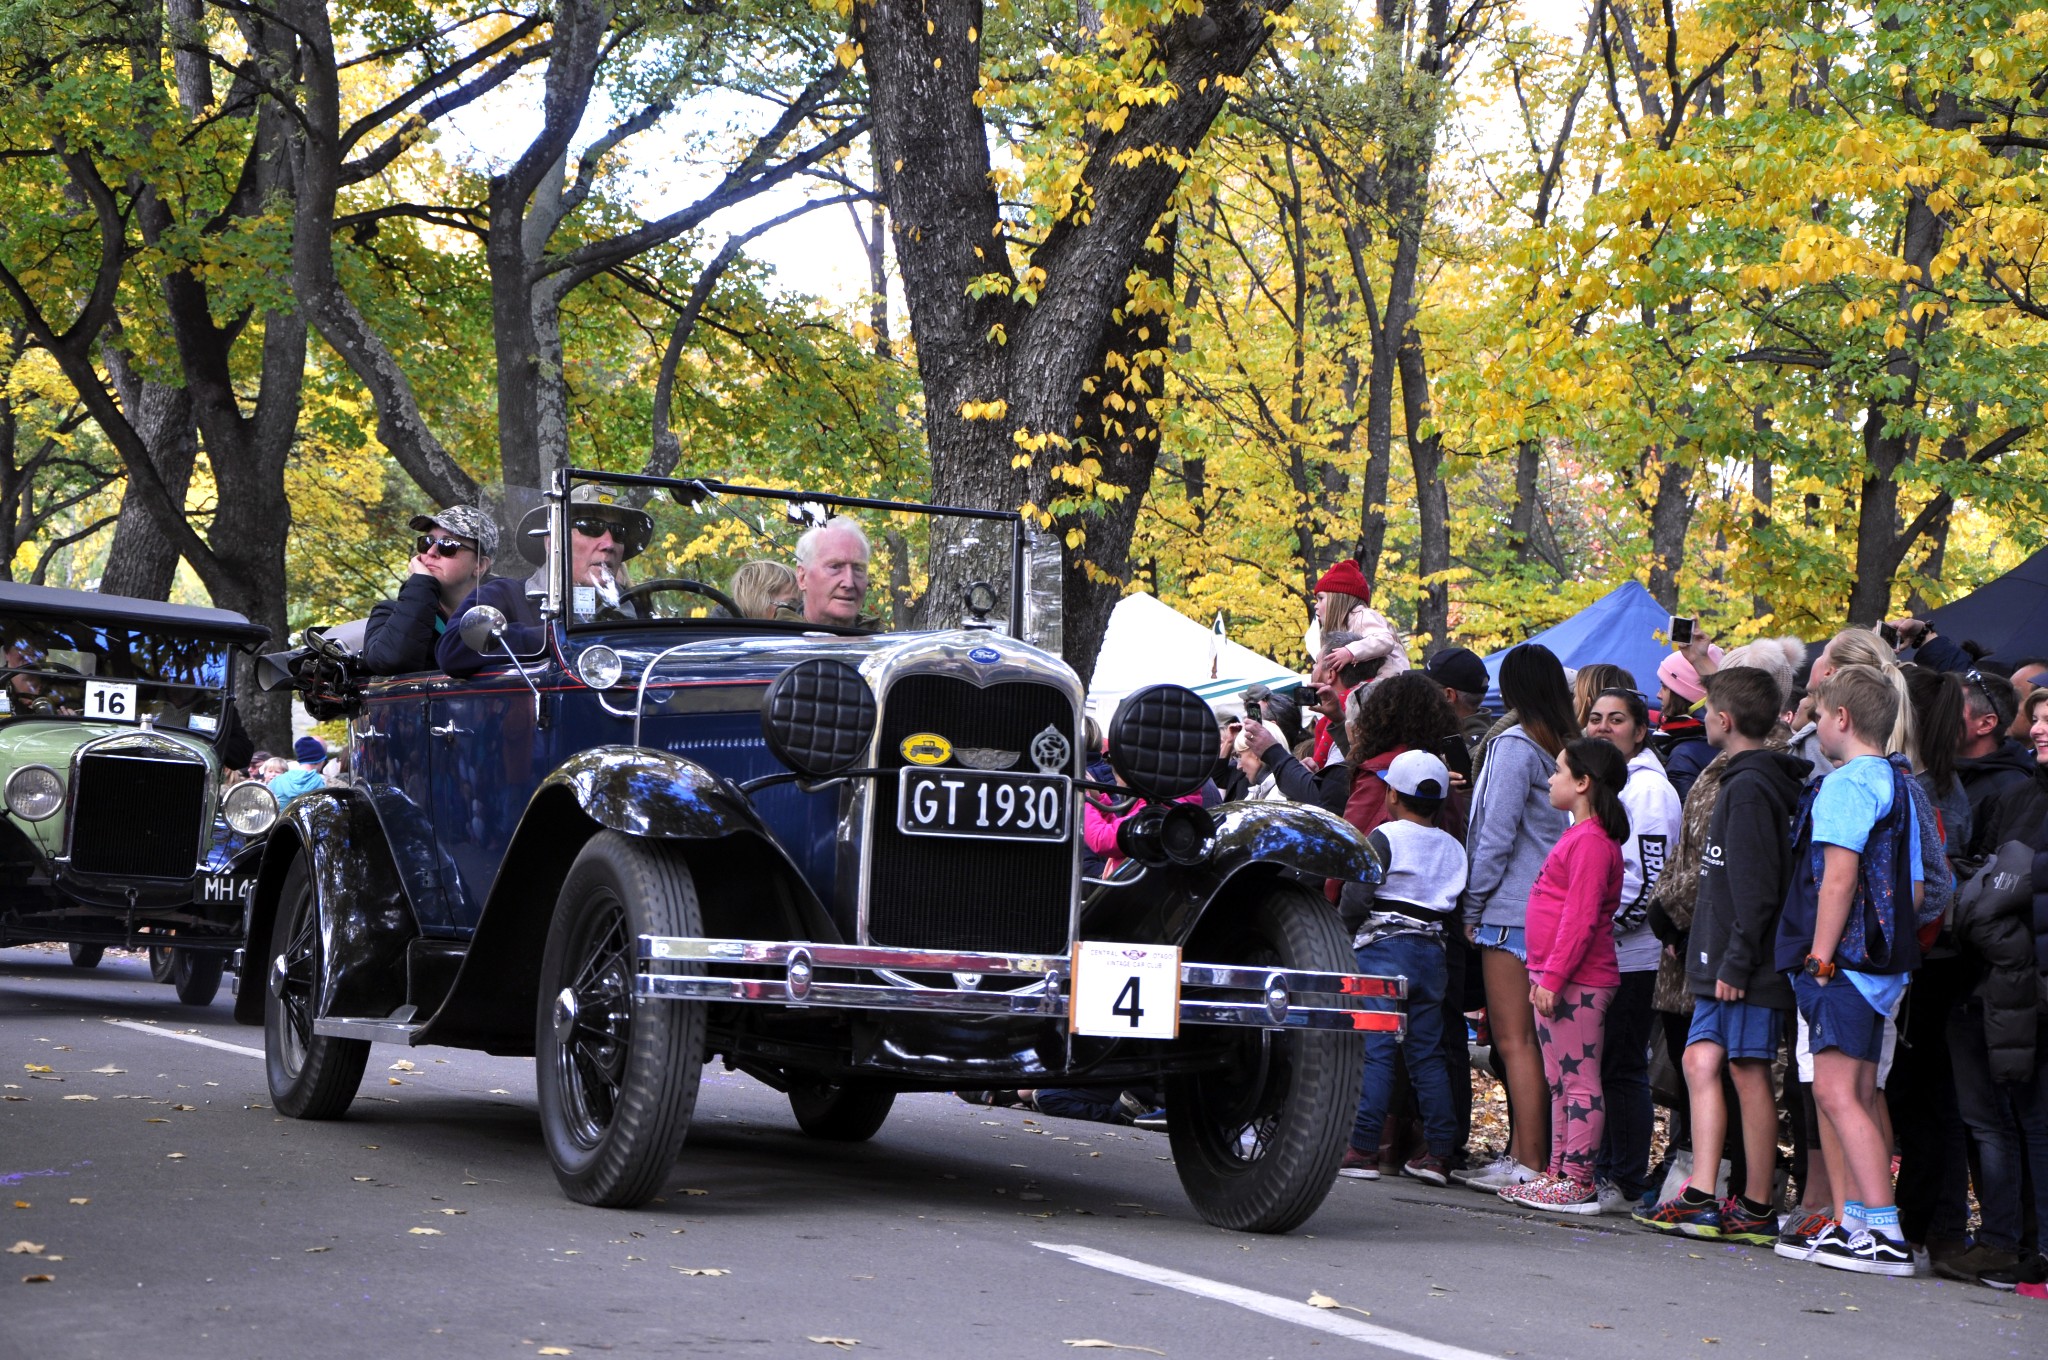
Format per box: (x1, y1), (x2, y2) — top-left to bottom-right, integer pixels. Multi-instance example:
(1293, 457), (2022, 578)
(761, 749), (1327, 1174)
(251, 471), (1405, 1231)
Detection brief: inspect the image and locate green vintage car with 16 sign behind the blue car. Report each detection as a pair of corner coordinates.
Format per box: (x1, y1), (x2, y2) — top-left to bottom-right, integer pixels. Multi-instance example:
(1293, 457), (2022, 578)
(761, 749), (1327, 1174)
(0, 582), (276, 1006)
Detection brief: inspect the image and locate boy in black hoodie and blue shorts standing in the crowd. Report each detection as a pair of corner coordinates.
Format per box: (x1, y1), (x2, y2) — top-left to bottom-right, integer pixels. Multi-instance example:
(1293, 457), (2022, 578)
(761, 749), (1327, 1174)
(1634, 668), (1806, 1247)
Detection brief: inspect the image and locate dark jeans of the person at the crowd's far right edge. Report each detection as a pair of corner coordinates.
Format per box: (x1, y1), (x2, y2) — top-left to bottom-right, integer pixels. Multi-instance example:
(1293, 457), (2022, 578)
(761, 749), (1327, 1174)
(1948, 997), (2048, 1251)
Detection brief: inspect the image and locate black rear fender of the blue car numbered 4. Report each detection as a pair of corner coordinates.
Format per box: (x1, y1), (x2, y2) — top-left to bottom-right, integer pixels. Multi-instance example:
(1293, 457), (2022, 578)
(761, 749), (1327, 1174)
(236, 789), (420, 1024)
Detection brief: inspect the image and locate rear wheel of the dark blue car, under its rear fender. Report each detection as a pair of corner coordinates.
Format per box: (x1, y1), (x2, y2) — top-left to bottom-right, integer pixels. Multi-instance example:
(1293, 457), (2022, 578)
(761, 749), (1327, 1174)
(266, 856), (371, 1118)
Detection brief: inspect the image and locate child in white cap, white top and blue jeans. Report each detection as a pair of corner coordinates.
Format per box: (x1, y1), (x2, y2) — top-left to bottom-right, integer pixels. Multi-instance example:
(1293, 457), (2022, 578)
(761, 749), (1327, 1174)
(1339, 750), (1464, 1186)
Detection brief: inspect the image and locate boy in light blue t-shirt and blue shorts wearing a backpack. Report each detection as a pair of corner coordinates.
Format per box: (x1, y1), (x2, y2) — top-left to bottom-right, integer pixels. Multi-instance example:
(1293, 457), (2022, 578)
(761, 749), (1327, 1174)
(1776, 666), (1923, 1276)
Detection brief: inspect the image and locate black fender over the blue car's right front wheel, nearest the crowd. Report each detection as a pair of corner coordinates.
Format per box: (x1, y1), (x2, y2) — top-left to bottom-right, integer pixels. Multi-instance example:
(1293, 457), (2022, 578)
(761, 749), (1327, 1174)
(1081, 803), (1380, 944)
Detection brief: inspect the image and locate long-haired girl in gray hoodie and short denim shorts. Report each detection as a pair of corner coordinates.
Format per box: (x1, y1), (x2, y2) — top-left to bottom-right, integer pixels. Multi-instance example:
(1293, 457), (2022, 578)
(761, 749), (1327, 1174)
(1460, 643), (1577, 1190)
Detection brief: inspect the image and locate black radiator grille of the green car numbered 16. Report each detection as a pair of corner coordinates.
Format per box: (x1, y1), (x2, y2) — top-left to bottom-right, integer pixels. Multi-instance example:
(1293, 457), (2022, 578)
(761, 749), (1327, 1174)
(72, 756), (207, 879)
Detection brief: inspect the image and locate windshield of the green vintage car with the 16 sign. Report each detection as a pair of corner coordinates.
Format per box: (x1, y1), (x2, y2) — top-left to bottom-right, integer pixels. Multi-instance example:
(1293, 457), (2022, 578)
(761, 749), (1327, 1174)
(0, 617), (227, 735)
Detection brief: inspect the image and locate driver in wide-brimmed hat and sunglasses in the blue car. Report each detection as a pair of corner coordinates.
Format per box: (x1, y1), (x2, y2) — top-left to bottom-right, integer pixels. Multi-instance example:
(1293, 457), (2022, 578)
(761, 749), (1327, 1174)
(434, 483), (653, 678)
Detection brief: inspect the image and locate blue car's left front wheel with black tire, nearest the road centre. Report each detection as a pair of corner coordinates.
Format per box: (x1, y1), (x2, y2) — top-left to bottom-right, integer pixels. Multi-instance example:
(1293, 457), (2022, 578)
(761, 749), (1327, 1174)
(535, 832), (707, 1208)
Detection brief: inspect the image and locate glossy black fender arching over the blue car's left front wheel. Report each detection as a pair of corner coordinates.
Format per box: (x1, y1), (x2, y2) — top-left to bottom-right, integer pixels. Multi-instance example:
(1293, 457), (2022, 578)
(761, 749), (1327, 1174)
(420, 746), (838, 1053)
